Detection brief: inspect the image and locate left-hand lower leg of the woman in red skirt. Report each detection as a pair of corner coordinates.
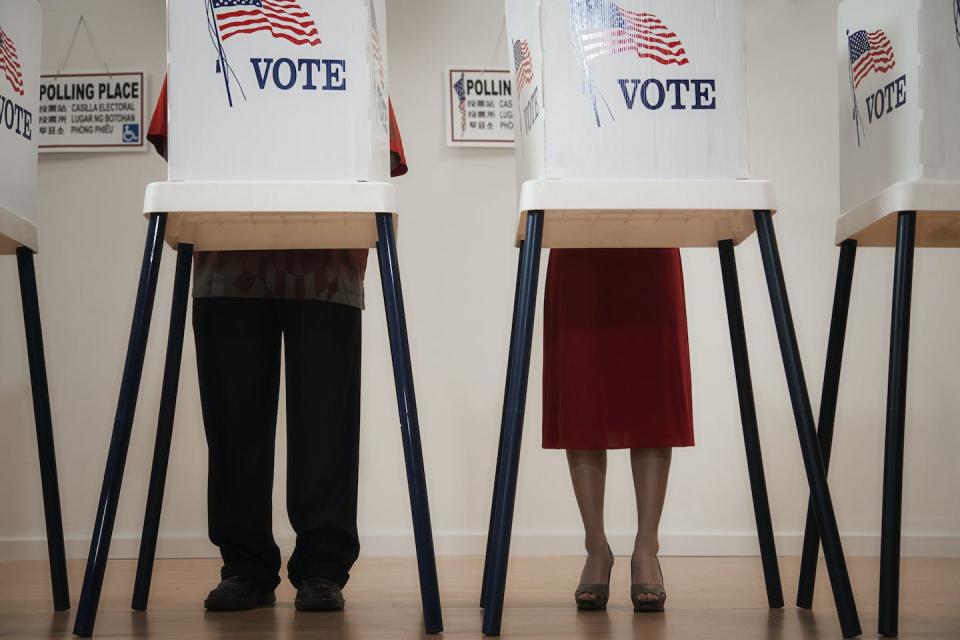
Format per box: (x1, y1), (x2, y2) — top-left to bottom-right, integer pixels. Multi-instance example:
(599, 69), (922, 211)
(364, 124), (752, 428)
(567, 449), (612, 600)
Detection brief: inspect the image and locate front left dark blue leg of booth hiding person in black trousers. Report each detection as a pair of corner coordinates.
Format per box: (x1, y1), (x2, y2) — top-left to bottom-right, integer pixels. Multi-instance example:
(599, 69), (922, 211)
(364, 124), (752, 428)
(73, 213), (167, 637)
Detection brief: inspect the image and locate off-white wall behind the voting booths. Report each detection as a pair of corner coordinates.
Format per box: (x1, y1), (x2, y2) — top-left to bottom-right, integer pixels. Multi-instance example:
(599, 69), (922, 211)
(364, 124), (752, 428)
(0, 0), (960, 557)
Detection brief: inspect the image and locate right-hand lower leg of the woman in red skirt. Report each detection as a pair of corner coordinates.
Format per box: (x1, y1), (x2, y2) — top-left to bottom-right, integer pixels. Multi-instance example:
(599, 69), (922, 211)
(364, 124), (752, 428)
(630, 449), (673, 600)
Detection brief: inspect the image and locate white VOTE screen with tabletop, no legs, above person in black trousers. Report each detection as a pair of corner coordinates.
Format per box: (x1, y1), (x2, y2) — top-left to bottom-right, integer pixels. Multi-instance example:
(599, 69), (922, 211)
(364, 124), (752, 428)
(150, 0), (396, 251)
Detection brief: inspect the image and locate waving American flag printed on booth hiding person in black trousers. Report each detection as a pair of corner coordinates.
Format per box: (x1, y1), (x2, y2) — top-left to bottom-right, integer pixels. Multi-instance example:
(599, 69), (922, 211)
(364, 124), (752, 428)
(212, 0), (320, 46)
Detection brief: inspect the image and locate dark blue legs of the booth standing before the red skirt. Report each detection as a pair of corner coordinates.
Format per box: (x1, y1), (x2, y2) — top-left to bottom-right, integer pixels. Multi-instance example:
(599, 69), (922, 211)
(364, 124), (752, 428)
(480, 210), (861, 638)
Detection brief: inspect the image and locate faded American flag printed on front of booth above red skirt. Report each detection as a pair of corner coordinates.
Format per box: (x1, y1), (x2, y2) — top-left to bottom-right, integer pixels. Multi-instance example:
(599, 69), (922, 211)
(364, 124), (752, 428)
(571, 0), (690, 66)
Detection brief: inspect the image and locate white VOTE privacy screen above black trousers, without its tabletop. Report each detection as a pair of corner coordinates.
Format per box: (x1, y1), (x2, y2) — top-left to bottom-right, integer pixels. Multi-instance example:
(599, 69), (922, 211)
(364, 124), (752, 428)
(167, 0), (390, 181)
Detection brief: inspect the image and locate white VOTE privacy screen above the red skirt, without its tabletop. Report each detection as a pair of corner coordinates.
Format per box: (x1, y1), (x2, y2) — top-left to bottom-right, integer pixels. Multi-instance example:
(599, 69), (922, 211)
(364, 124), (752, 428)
(506, 0), (748, 184)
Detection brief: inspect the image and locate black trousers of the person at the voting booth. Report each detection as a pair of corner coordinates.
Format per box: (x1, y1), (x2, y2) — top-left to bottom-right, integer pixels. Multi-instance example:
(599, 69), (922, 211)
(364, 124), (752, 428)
(193, 298), (361, 588)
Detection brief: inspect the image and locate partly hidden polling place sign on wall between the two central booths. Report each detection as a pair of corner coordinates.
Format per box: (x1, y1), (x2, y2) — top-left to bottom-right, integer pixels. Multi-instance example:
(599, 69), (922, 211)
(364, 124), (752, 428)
(444, 67), (515, 147)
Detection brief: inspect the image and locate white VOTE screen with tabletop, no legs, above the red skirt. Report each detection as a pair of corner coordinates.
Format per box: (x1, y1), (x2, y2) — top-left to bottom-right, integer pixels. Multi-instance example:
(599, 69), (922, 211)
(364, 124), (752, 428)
(507, 0), (776, 247)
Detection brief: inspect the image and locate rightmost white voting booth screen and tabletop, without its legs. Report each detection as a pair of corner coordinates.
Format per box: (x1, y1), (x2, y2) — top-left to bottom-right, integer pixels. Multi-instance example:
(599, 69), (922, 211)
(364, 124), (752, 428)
(837, 0), (960, 247)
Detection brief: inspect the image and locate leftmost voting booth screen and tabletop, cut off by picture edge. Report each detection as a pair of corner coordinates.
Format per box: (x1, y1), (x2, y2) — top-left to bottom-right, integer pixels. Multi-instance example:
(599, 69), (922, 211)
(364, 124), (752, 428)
(0, 0), (41, 253)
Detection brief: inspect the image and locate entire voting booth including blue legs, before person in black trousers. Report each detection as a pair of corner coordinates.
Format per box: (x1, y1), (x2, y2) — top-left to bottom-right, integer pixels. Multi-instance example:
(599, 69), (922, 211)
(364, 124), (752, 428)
(74, 0), (443, 636)
